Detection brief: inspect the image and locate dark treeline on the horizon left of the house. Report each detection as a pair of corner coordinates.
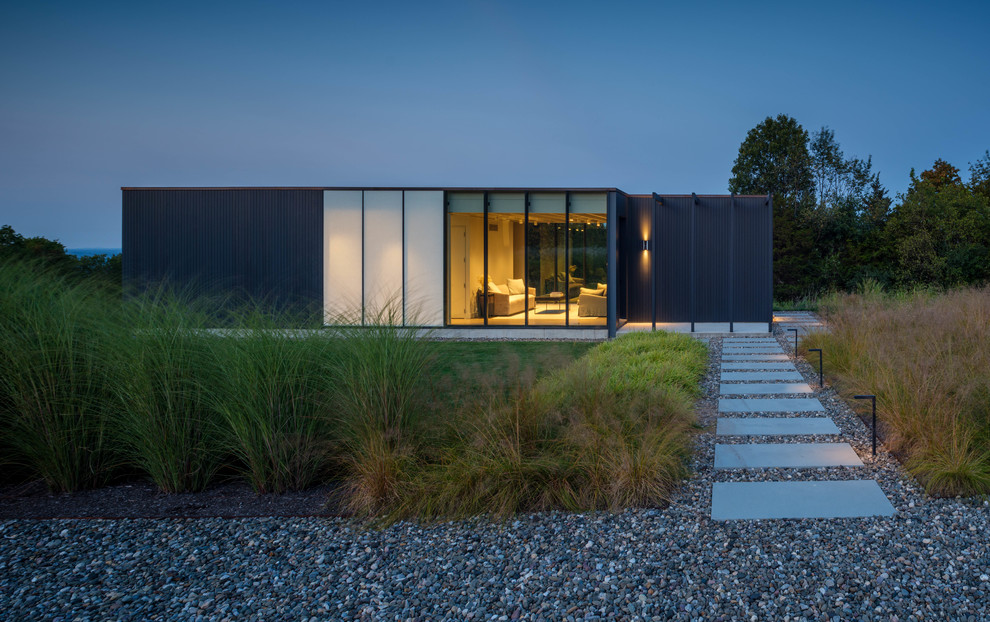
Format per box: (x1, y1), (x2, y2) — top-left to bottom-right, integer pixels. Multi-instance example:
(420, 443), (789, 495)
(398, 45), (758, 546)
(0, 225), (122, 289)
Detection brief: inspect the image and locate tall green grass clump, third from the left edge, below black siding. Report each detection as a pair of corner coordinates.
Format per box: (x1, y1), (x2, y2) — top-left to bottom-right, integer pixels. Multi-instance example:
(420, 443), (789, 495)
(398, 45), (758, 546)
(202, 307), (331, 493)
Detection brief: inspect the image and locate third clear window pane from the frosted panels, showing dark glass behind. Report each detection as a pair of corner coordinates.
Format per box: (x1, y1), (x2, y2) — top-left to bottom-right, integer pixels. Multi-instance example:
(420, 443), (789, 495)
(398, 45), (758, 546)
(526, 192), (568, 325)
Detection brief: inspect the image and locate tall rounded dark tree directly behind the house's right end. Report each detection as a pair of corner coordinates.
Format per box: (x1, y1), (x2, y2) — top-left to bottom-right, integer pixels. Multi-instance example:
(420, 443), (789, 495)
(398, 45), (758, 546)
(729, 114), (821, 298)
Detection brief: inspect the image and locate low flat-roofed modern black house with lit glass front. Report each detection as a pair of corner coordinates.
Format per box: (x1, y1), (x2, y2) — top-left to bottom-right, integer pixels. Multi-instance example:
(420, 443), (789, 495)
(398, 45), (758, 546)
(121, 188), (773, 337)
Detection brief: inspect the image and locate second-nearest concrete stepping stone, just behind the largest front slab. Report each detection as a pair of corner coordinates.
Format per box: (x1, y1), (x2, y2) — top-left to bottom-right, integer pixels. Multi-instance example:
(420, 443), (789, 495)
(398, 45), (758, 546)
(715, 443), (863, 469)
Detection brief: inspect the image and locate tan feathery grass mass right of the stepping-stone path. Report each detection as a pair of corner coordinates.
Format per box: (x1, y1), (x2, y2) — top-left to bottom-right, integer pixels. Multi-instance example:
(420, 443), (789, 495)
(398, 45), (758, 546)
(803, 287), (990, 495)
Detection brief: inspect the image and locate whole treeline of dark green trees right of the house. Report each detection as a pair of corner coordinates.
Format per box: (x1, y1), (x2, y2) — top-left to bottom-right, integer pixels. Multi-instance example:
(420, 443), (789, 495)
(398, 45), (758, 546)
(729, 114), (990, 300)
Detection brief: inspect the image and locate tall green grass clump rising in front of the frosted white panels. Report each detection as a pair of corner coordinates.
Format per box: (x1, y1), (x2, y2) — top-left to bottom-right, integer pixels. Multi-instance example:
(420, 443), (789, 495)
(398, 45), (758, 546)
(327, 297), (434, 514)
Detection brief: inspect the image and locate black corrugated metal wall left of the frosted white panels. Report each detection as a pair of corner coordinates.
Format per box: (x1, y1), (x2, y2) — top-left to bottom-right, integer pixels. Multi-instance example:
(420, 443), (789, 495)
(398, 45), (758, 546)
(123, 188), (323, 309)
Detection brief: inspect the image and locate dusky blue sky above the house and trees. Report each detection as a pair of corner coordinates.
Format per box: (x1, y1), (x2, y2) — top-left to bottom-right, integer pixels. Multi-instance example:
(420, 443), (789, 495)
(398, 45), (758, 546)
(0, 0), (990, 247)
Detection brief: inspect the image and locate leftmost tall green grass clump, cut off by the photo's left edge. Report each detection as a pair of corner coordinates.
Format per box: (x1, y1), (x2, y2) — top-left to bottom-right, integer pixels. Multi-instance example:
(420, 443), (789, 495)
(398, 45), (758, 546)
(0, 263), (119, 492)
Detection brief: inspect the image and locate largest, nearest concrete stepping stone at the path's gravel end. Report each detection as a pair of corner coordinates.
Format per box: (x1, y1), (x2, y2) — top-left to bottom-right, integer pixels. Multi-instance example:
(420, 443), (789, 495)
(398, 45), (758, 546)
(712, 479), (897, 520)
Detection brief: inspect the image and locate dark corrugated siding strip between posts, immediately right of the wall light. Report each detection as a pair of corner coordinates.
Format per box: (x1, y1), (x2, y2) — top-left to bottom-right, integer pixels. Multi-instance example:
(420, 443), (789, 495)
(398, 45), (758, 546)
(654, 197), (692, 322)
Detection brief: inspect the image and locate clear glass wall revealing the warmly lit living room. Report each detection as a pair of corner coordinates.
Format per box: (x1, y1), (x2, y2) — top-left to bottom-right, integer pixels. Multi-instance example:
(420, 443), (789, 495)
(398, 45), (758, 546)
(447, 192), (608, 326)
